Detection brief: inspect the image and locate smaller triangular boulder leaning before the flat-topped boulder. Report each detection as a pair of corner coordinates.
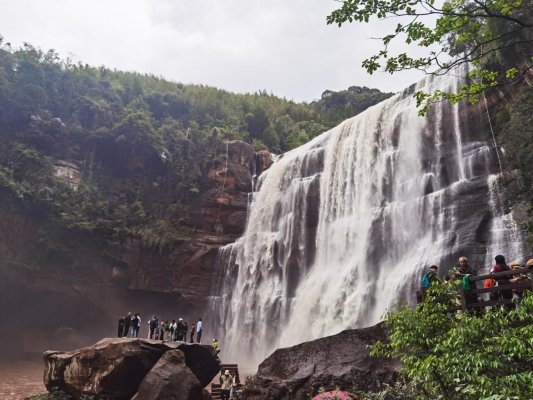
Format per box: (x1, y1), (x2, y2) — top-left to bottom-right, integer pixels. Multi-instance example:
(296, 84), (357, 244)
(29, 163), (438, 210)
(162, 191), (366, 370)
(132, 349), (205, 400)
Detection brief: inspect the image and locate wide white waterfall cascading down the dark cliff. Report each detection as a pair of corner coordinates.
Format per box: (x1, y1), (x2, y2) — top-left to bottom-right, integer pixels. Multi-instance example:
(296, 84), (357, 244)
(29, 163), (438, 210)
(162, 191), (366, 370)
(210, 68), (521, 365)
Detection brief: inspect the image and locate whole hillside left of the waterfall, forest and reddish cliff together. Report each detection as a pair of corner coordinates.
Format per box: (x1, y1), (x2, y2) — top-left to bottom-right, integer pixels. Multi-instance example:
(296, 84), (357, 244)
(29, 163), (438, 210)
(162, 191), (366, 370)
(0, 42), (390, 356)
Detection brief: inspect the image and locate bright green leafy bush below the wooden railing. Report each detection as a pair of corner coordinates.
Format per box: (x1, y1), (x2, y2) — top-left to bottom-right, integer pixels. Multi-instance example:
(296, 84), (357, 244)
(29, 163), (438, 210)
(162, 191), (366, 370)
(371, 285), (533, 400)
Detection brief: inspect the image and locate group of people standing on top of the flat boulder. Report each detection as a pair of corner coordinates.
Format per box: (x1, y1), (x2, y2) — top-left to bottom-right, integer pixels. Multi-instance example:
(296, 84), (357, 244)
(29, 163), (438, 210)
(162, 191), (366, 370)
(118, 312), (204, 343)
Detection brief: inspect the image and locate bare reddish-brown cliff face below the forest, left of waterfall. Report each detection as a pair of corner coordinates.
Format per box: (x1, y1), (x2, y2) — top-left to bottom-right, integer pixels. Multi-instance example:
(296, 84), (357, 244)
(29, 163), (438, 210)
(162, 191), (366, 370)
(0, 141), (268, 356)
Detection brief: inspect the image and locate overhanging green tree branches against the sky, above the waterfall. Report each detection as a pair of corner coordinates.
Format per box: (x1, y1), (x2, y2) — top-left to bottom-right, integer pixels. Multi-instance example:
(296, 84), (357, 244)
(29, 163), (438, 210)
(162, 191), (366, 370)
(327, 0), (533, 113)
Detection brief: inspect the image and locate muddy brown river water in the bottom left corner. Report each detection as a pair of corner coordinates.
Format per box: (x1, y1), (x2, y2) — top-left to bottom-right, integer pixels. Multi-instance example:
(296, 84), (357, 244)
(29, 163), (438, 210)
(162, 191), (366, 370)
(0, 361), (46, 400)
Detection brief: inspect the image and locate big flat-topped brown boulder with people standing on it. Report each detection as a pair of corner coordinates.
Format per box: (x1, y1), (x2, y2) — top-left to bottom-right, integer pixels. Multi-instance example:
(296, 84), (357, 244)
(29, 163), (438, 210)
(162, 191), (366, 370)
(44, 338), (220, 400)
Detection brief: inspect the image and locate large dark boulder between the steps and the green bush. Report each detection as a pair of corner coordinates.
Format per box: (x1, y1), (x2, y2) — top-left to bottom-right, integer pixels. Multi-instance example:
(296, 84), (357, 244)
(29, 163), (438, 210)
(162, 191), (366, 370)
(244, 325), (400, 400)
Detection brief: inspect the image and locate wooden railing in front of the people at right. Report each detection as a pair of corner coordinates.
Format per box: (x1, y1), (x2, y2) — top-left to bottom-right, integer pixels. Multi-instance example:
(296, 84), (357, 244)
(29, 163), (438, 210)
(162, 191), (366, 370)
(417, 268), (533, 311)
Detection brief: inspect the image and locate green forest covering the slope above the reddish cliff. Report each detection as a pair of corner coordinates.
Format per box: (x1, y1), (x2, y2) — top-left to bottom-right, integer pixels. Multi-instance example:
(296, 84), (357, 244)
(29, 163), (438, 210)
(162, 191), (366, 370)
(0, 37), (391, 266)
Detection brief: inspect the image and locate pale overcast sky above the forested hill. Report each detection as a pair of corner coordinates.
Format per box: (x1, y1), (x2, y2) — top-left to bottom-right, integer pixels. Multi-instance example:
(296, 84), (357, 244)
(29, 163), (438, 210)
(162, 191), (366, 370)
(0, 0), (420, 101)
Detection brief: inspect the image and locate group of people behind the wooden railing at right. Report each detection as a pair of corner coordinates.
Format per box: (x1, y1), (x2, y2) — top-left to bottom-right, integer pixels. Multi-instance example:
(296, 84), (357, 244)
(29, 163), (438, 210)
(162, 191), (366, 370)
(421, 255), (533, 308)
